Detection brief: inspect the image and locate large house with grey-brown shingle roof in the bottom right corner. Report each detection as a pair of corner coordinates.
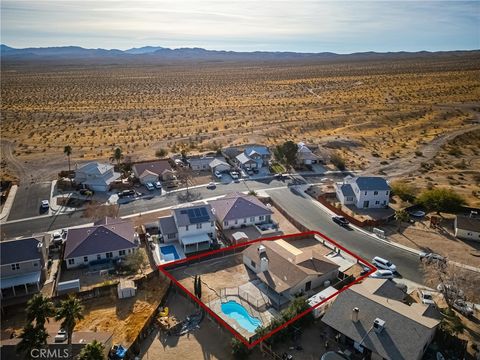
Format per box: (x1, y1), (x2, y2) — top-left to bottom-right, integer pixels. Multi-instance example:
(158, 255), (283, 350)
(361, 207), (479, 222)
(322, 278), (439, 360)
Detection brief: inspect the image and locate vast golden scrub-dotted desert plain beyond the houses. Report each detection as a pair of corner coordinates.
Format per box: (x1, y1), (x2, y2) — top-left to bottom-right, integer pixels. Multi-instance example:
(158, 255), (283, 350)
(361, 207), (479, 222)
(1, 51), (480, 202)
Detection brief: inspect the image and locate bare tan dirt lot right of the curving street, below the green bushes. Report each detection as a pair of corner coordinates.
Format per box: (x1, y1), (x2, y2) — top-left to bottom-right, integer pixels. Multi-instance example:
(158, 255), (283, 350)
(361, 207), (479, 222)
(382, 219), (480, 267)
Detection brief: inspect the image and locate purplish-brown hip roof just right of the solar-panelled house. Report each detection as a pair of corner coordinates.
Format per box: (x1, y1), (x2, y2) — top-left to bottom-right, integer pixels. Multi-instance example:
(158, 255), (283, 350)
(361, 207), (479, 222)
(209, 193), (273, 222)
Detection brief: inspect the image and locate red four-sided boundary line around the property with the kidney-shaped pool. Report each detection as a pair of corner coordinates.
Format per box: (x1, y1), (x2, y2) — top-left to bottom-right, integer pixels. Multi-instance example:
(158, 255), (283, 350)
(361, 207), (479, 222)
(158, 231), (377, 349)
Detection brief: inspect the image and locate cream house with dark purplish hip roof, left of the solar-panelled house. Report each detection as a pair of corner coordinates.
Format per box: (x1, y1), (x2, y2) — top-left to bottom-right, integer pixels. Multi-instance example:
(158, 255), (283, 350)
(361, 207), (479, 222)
(63, 217), (139, 269)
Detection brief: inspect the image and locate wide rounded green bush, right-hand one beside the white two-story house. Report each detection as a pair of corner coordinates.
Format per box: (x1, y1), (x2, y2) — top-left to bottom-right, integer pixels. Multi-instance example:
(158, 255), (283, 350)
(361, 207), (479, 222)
(417, 188), (465, 213)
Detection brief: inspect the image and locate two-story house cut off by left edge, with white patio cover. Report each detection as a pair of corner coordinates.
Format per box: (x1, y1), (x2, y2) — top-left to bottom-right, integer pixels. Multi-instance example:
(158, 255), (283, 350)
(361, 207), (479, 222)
(0, 234), (50, 298)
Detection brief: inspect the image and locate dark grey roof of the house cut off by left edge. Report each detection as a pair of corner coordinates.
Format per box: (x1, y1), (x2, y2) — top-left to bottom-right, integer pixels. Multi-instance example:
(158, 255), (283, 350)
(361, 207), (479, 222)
(0, 237), (42, 265)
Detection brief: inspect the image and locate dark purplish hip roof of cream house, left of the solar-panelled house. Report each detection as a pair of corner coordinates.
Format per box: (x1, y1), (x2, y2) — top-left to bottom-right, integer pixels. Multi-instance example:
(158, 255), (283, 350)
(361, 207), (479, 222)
(64, 219), (137, 259)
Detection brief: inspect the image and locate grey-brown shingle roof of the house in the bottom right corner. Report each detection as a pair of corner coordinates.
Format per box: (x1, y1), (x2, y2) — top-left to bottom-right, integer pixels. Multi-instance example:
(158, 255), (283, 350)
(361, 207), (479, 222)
(322, 279), (439, 360)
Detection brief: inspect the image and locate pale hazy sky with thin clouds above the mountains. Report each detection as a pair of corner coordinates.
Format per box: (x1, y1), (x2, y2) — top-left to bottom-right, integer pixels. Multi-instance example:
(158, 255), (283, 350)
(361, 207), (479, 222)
(1, 0), (480, 53)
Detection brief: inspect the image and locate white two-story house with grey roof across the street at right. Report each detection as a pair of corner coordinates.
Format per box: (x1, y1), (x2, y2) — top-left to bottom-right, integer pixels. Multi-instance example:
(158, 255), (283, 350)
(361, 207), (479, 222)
(335, 176), (390, 209)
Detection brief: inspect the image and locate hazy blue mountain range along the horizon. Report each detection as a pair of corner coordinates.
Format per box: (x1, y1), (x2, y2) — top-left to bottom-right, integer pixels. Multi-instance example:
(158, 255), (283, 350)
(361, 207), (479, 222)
(0, 44), (479, 64)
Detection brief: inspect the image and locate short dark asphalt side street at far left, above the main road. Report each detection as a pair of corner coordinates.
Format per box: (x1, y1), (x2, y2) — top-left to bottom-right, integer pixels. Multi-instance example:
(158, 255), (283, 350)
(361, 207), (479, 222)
(8, 182), (52, 221)
